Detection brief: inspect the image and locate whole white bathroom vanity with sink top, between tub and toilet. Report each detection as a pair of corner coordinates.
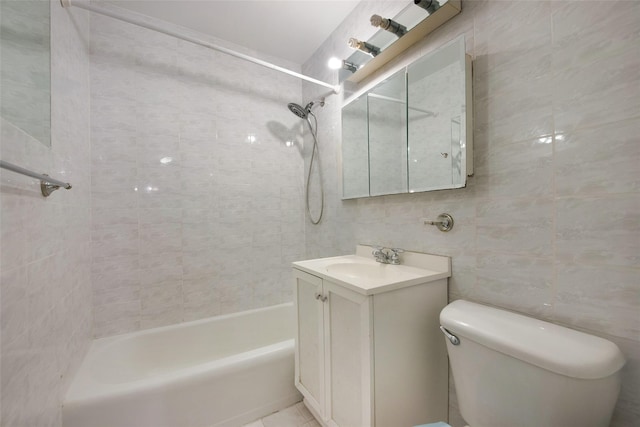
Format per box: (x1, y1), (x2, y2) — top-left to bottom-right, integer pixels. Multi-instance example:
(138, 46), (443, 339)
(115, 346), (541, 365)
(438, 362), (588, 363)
(293, 245), (451, 427)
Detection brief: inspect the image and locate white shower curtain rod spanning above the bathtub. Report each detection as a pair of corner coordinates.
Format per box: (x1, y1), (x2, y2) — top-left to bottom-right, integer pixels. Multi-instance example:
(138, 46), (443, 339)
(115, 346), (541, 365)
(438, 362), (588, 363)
(60, 0), (340, 94)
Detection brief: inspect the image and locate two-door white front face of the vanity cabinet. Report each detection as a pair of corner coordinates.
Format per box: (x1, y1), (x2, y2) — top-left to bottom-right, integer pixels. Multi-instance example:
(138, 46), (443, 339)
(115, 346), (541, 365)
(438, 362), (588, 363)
(295, 270), (372, 426)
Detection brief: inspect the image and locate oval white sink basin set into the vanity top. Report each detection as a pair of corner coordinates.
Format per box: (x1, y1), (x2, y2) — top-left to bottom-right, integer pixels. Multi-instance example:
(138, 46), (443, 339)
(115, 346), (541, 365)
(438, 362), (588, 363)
(326, 262), (421, 282)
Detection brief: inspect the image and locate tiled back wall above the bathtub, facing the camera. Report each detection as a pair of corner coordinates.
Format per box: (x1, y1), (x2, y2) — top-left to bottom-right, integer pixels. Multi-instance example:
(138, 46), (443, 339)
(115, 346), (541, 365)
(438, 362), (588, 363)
(91, 7), (305, 337)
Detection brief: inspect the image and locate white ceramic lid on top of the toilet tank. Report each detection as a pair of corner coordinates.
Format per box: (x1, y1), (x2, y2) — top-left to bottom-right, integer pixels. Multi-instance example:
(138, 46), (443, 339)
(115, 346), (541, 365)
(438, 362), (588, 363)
(440, 300), (625, 379)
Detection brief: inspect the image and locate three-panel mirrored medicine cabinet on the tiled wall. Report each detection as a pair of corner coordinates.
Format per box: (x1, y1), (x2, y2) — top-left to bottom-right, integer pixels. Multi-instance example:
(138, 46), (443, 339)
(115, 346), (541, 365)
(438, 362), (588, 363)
(342, 36), (473, 199)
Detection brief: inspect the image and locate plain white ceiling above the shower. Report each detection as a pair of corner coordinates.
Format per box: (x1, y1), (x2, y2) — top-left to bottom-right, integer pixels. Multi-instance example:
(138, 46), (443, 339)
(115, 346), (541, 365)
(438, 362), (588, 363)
(105, 0), (359, 64)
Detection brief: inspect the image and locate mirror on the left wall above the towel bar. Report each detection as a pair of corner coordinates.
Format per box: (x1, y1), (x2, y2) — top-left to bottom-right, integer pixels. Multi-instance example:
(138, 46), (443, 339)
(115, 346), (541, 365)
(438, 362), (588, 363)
(0, 0), (51, 146)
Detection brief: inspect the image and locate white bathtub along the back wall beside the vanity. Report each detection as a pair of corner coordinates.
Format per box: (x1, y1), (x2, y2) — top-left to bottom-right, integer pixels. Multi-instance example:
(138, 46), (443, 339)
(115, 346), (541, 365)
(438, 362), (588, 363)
(62, 303), (302, 427)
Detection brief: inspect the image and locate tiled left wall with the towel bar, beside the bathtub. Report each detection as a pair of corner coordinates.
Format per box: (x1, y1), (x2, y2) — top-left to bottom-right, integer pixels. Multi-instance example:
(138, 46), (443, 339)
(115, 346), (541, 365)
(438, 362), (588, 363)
(0, 0), (92, 427)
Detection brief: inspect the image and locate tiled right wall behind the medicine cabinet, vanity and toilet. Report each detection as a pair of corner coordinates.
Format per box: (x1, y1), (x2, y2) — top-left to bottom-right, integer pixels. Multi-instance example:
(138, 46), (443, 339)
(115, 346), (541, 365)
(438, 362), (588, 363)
(303, 1), (640, 427)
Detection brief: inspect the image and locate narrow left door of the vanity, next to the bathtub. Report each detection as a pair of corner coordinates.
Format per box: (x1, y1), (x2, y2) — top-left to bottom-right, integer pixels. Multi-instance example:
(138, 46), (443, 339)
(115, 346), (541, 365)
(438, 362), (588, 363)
(294, 270), (326, 415)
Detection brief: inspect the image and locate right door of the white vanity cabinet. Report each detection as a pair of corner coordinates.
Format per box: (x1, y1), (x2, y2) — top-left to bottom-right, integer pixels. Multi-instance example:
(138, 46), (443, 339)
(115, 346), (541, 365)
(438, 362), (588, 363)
(323, 281), (373, 427)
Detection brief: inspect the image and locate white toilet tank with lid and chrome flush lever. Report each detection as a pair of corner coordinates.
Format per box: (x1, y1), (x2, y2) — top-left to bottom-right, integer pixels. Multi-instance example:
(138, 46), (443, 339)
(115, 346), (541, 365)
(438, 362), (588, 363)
(440, 300), (625, 427)
